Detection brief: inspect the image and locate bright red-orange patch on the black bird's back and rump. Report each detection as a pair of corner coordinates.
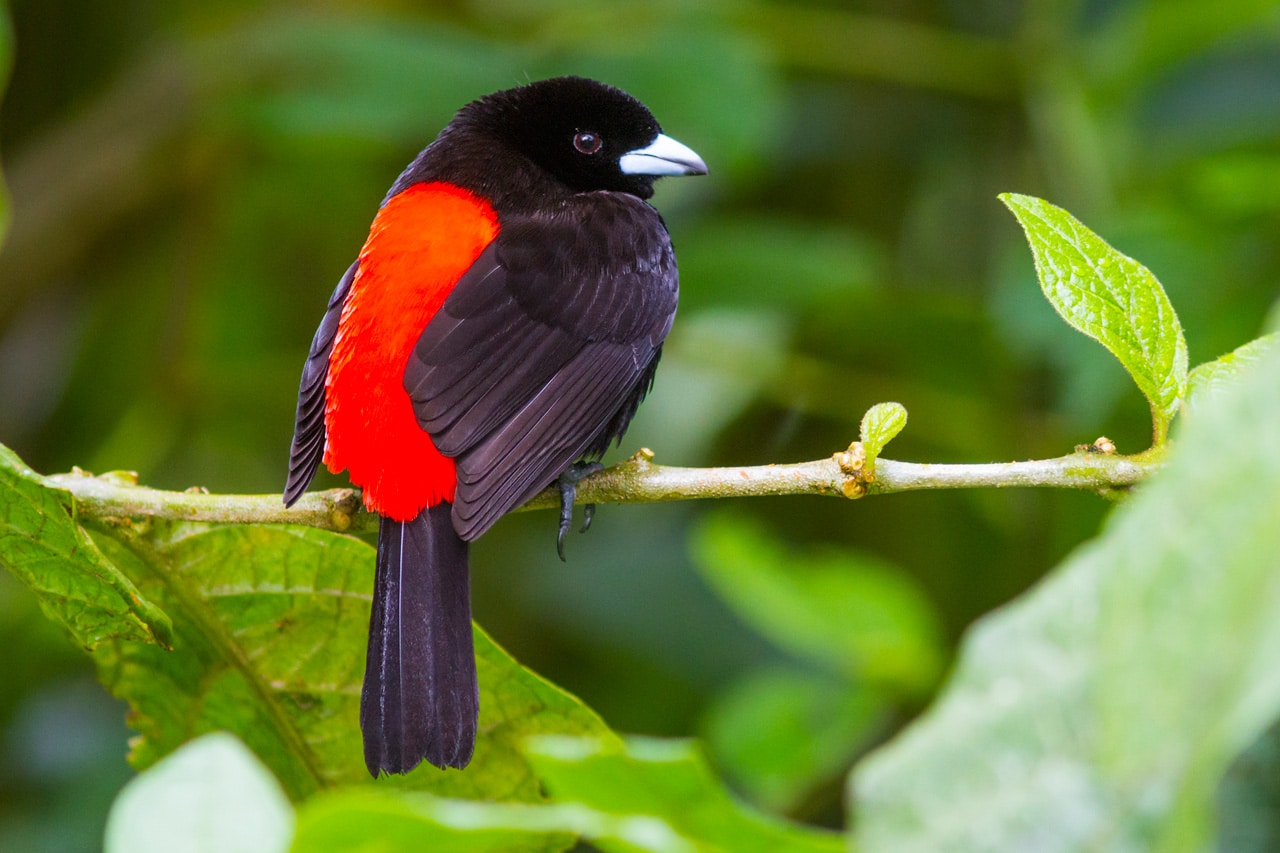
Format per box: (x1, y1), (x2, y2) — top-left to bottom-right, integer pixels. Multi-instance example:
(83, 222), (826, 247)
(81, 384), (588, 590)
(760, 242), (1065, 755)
(324, 182), (498, 521)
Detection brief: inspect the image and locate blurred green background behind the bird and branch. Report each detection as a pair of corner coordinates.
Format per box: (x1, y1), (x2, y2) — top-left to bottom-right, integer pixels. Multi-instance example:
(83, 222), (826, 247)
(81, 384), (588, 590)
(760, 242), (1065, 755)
(0, 0), (1280, 852)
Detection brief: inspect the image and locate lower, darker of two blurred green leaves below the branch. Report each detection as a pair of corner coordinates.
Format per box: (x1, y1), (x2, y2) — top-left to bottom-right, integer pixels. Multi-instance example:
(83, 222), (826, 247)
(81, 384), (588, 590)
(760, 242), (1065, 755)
(704, 669), (892, 813)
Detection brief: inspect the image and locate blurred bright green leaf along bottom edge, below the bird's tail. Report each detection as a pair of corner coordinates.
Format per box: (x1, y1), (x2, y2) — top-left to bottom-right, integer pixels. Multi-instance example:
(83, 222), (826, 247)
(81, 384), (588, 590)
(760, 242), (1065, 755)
(293, 736), (844, 853)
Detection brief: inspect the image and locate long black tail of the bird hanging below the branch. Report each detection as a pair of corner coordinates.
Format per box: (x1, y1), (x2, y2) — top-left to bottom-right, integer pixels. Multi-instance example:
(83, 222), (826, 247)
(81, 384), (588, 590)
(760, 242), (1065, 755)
(360, 503), (480, 776)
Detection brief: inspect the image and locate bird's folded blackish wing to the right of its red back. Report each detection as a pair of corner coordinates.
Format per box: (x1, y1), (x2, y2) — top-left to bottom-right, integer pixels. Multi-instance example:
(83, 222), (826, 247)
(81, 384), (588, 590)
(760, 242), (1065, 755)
(404, 193), (677, 539)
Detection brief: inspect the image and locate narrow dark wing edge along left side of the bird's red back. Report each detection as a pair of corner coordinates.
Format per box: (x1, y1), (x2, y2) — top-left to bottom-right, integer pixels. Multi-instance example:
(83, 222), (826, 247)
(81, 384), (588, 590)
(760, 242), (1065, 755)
(284, 264), (358, 506)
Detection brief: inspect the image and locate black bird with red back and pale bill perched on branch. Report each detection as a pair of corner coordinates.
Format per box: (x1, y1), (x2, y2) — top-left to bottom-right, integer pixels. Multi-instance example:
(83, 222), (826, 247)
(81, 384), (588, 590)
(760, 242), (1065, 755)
(284, 77), (707, 777)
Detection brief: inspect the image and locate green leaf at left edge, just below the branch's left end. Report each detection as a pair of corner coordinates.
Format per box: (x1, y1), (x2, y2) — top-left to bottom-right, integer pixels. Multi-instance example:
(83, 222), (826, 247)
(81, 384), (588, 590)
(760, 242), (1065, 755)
(0, 444), (173, 648)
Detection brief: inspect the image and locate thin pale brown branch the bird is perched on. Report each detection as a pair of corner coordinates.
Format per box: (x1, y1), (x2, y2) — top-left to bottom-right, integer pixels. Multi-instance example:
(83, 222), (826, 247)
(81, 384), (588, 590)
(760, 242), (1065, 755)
(45, 450), (1160, 532)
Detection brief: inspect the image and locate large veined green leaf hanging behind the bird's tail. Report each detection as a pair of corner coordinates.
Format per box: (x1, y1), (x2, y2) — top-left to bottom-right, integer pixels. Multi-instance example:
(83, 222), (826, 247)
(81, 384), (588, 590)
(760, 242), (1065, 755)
(85, 514), (608, 800)
